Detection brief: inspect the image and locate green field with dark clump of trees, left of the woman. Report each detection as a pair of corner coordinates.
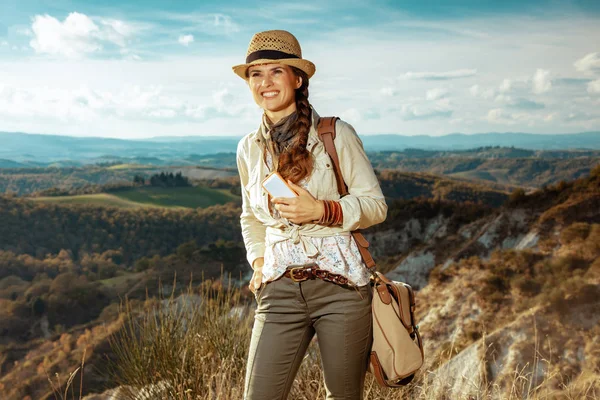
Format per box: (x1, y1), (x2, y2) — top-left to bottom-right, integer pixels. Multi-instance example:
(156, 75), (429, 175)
(32, 186), (238, 208)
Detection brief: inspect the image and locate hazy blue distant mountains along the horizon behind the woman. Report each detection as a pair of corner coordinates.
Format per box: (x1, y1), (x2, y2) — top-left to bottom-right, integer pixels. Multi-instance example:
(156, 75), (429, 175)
(0, 132), (600, 164)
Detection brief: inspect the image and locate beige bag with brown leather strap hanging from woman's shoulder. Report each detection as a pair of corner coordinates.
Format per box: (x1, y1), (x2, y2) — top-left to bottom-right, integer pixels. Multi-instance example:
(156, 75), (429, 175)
(317, 117), (424, 387)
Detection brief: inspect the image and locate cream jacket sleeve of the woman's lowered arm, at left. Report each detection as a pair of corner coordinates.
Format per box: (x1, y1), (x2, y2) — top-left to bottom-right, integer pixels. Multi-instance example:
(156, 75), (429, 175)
(236, 138), (267, 267)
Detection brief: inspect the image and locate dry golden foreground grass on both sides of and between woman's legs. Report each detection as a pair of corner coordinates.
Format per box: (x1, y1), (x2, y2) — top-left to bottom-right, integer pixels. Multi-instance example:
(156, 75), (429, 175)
(82, 281), (600, 400)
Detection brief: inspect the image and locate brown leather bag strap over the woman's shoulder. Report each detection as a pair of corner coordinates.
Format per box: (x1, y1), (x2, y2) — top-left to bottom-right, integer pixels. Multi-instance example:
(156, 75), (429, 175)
(317, 117), (375, 270)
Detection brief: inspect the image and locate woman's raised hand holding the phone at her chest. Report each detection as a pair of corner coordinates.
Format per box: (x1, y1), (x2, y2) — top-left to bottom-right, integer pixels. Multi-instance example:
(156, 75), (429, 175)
(271, 180), (325, 224)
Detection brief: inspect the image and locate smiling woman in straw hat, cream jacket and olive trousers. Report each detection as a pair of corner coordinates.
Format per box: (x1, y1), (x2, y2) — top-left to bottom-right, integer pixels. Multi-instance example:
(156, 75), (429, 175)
(233, 31), (387, 400)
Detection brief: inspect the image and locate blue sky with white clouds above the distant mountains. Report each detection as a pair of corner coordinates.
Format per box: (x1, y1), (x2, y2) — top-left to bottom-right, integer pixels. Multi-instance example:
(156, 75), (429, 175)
(0, 0), (600, 138)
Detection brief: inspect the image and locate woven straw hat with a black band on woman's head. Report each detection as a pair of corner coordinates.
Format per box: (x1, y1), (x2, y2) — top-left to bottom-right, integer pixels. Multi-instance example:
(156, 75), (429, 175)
(232, 30), (316, 80)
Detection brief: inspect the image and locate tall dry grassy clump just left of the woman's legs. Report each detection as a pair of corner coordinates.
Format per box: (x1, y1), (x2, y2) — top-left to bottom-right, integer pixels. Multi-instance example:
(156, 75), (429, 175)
(110, 281), (252, 399)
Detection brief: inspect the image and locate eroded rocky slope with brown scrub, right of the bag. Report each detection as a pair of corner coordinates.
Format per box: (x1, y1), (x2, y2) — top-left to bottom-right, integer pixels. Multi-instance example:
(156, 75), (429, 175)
(369, 171), (600, 399)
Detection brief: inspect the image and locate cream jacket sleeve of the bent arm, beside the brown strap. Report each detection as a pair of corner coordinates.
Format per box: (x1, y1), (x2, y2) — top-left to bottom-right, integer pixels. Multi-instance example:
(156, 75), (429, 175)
(335, 121), (388, 231)
